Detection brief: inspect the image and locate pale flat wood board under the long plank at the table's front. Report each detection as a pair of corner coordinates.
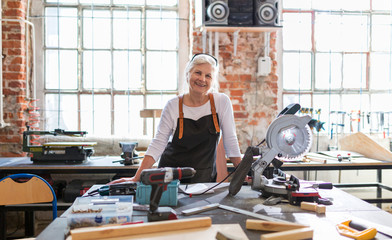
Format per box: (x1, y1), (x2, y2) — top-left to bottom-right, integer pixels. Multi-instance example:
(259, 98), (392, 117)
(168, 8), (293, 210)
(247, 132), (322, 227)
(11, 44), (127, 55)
(67, 224), (248, 240)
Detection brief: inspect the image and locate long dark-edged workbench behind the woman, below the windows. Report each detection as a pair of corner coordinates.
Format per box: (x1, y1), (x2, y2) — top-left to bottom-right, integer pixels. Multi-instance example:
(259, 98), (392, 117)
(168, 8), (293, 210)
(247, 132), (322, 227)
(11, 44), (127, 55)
(0, 156), (392, 204)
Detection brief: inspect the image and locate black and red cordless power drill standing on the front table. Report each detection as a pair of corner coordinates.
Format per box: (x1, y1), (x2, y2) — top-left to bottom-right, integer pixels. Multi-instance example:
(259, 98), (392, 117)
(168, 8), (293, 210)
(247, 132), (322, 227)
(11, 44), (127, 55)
(140, 167), (196, 222)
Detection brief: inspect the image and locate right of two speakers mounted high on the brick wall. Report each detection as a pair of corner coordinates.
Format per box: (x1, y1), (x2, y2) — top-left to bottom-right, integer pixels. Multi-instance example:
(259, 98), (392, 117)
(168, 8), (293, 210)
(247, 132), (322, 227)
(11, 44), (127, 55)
(253, 0), (279, 26)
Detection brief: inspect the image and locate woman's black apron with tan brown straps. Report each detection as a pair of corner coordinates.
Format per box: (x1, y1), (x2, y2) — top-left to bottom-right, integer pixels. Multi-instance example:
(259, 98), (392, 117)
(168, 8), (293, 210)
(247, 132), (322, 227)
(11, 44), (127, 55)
(158, 93), (220, 183)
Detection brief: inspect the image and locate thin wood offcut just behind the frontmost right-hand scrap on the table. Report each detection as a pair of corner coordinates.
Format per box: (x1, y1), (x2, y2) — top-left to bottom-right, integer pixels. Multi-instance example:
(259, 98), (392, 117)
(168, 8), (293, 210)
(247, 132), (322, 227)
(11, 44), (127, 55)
(246, 219), (308, 232)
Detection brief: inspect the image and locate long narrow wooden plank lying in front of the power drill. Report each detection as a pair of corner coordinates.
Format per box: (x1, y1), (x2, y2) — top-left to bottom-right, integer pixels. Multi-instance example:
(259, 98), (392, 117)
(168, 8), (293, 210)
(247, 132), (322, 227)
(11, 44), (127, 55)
(70, 217), (212, 240)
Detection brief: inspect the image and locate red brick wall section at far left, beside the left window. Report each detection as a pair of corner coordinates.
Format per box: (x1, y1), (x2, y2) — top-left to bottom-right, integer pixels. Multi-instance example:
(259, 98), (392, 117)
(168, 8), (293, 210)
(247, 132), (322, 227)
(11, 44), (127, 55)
(0, 0), (28, 157)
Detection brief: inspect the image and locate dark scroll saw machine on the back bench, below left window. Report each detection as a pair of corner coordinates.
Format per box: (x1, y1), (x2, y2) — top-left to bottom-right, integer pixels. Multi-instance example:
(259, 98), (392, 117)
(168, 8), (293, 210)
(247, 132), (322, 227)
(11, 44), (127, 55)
(23, 126), (97, 163)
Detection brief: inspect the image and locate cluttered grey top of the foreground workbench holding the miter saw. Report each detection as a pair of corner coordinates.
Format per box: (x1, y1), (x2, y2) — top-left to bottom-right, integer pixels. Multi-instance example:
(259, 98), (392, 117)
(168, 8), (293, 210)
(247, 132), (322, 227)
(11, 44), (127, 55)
(36, 185), (392, 240)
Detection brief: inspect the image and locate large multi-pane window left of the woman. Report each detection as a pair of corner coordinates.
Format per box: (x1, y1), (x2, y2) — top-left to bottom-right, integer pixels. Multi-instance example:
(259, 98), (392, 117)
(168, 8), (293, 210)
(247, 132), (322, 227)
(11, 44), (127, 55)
(32, 0), (188, 137)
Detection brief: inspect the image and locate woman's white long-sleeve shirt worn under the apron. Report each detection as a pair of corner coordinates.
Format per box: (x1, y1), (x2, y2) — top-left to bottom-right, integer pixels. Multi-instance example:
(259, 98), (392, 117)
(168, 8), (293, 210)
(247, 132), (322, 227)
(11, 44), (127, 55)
(146, 93), (241, 161)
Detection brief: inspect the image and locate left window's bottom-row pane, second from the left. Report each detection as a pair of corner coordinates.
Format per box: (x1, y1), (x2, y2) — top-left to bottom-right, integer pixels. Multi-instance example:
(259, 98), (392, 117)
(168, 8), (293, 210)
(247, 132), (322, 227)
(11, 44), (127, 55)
(80, 95), (111, 136)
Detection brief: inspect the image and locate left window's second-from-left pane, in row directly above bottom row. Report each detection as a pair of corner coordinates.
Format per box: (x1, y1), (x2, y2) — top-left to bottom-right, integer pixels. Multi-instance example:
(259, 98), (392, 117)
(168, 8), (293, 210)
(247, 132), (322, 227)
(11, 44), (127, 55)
(83, 51), (112, 89)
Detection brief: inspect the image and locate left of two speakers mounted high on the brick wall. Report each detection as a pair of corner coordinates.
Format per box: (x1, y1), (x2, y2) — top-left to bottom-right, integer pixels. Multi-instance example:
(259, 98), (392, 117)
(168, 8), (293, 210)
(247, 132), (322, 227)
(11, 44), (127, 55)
(195, 0), (230, 27)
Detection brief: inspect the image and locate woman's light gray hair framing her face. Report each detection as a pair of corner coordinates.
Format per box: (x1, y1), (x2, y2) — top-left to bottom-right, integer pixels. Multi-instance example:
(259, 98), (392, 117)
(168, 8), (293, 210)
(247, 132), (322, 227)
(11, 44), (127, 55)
(183, 54), (219, 93)
